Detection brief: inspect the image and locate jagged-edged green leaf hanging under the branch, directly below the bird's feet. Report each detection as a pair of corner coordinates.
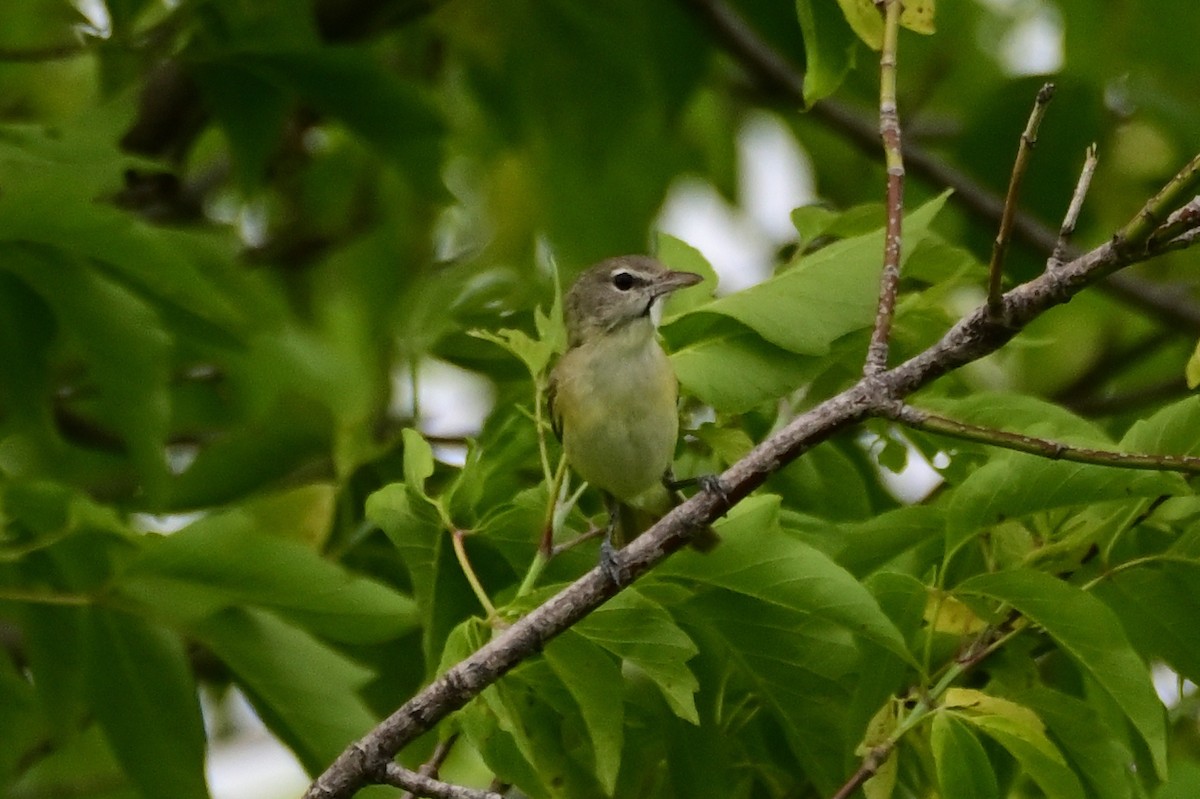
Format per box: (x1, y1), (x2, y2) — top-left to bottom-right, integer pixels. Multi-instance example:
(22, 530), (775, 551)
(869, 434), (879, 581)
(572, 588), (700, 725)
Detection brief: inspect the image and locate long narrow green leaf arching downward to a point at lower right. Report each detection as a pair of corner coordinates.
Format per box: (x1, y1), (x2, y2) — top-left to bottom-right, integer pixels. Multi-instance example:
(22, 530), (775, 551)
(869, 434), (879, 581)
(955, 570), (1166, 776)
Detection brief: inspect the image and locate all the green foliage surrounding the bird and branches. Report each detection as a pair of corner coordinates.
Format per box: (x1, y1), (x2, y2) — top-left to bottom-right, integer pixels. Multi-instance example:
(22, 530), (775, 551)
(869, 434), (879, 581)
(0, 0), (1200, 799)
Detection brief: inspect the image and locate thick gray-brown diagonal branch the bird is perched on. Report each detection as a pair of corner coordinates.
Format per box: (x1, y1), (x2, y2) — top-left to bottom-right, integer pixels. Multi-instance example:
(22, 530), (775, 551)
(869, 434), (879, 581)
(305, 163), (1200, 799)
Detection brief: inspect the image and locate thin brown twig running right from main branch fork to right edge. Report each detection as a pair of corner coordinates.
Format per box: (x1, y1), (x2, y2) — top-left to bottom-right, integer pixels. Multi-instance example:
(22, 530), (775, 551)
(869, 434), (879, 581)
(890, 404), (1200, 474)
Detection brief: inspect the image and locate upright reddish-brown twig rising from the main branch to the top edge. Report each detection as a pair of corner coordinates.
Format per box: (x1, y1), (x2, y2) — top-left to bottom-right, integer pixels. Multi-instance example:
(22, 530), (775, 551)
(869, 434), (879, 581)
(863, 0), (904, 377)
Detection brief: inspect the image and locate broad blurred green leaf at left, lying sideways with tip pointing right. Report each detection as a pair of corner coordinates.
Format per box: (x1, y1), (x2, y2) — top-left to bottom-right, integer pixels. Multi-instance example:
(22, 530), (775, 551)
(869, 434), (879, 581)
(114, 511), (416, 643)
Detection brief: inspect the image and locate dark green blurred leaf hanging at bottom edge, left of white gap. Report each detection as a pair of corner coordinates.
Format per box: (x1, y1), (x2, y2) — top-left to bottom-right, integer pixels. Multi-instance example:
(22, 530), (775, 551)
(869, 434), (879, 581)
(85, 608), (209, 799)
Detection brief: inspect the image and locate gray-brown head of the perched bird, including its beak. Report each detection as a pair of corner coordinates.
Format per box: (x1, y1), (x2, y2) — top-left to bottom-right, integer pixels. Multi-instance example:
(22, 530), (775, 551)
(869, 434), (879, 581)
(564, 256), (703, 347)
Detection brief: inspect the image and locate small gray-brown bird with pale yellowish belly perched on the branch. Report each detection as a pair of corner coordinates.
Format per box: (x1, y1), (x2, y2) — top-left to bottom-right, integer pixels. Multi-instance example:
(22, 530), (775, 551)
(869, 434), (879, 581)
(548, 256), (718, 583)
